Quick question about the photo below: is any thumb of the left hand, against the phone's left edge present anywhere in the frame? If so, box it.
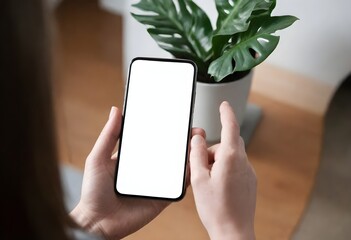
[88,107,122,164]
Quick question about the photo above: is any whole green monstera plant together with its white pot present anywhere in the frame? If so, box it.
[132,0,297,142]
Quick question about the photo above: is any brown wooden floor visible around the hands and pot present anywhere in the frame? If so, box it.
[56,0,323,240]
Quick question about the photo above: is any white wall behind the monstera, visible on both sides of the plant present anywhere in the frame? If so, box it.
[101,0,351,86]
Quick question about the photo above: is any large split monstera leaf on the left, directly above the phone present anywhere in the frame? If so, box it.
[132,0,213,71]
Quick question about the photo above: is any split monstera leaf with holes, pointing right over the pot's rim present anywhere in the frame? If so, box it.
[208,16,297,81]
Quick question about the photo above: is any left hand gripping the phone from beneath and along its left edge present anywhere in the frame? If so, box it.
[70,107,169,239]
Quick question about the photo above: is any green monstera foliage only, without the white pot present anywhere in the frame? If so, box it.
[132,0,297,83]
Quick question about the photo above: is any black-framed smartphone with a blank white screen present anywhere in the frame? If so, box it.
[115,58,197,200]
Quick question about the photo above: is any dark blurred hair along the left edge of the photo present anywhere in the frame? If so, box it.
[0,0,69,240]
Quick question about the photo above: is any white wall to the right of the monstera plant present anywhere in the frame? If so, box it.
[268,0,351,86]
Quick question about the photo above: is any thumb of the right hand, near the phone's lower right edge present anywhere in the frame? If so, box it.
[190,134,209,183]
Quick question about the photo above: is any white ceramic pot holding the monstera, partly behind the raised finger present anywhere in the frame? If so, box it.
[193,70,253,142]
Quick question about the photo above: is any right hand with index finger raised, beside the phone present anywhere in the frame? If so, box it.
[190,102,256,240]
